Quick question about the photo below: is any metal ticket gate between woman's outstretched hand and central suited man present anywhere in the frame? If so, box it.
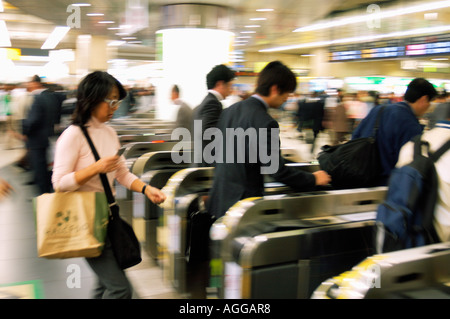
[158,163,332,294]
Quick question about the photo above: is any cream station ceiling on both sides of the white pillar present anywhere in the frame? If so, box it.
[0,0,450,54]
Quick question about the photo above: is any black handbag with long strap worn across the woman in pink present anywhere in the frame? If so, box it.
[81,127,142,269]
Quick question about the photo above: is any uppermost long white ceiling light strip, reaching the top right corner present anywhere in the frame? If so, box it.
[293,0,450,32]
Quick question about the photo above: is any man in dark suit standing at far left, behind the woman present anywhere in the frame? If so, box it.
[22,76,60,195]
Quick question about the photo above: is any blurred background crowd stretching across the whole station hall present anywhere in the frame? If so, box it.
[0,75,450,198]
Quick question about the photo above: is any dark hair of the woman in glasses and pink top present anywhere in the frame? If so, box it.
[72,71,127,125]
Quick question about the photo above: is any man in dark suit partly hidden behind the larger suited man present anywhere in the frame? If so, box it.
[192,64,235,167]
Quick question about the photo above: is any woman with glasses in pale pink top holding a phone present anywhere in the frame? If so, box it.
[52,71,166,298]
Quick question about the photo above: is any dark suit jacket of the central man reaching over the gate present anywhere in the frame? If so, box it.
[207,97,315,218]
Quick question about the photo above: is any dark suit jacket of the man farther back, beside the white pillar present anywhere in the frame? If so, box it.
[192,93,223,167]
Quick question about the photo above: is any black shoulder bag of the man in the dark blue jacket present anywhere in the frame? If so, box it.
[317,105,386,189]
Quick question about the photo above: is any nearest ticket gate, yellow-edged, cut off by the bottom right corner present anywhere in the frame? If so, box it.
[312,242,450,299]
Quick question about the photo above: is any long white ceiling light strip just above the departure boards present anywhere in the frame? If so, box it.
[259,25,450,52]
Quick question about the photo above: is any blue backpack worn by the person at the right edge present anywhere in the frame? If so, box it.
[375,135,450,253]
